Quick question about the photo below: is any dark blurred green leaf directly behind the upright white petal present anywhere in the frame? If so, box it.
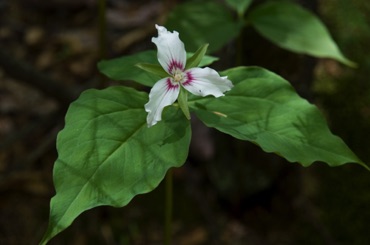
[166,1,243,53]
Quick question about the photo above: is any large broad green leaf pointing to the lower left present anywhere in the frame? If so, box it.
[41,87,191,244]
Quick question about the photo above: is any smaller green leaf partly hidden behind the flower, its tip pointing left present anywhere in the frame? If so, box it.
[98,50,218,87]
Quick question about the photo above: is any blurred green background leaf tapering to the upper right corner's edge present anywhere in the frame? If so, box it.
[249,1,355,67]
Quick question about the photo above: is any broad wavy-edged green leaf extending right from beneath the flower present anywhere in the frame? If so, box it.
[189,67,367,168]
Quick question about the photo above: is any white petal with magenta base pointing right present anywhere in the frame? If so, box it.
[182,67,233,97]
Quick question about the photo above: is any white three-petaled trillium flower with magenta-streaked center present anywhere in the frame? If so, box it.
[145,25,233,127]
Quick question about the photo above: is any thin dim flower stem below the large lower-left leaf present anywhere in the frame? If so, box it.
[164,169,173,245]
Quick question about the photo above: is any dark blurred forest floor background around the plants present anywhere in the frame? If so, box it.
[0,0,370,245]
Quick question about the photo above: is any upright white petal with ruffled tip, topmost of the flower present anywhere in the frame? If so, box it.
[152,25,186,75]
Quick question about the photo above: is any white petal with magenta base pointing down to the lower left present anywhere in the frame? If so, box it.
[145,78,180,127]
